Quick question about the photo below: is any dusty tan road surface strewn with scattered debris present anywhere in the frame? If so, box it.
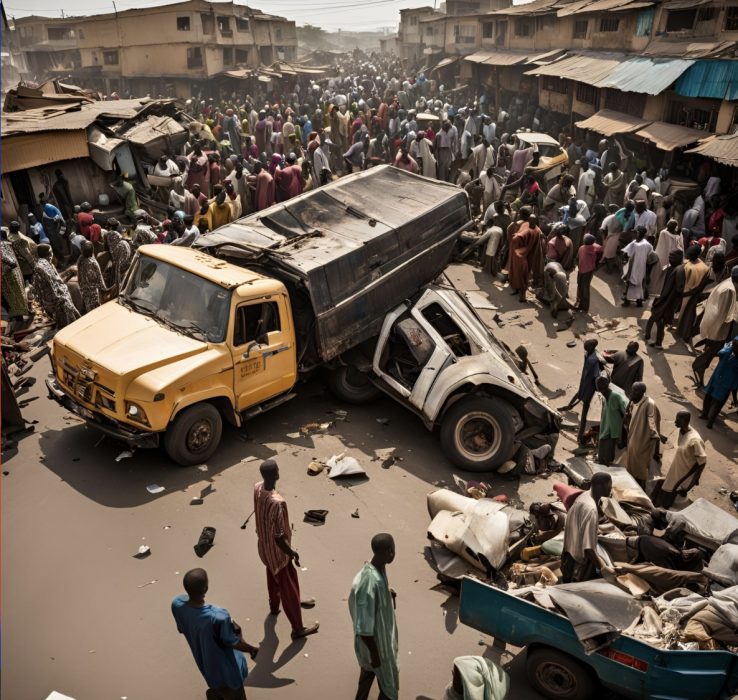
[2,266,738,700]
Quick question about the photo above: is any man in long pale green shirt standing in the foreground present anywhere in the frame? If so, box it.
[349,534,400,700]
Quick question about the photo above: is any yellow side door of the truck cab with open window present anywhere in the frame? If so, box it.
[231,295,297,411]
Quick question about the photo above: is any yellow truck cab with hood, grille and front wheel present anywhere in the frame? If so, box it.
[47,245,297,464]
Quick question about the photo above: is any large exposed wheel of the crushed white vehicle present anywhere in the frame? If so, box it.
[441,396,515,472]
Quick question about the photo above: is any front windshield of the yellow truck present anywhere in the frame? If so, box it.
[120,255,231,343]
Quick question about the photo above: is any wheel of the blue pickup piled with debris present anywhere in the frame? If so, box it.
[525,647,598,700]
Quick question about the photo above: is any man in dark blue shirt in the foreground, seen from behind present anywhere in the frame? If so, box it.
[172,569,259,700]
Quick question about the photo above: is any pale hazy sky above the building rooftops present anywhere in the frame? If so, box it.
[5,0,441,31]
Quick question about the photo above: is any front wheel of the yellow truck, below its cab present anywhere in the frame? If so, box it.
[164,403,223,467]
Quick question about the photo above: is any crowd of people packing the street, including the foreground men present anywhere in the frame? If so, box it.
[0,53,738,698]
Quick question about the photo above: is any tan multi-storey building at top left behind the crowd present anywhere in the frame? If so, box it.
[16,0,297,97]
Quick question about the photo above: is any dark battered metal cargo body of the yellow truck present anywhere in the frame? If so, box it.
[196,165,471,365]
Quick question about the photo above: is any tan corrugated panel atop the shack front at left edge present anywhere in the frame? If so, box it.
[3,129,90,173]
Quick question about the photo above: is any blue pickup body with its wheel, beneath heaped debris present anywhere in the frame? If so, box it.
[459,578,738,700]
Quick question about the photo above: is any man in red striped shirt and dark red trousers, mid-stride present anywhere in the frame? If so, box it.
[254,459,320,639]
